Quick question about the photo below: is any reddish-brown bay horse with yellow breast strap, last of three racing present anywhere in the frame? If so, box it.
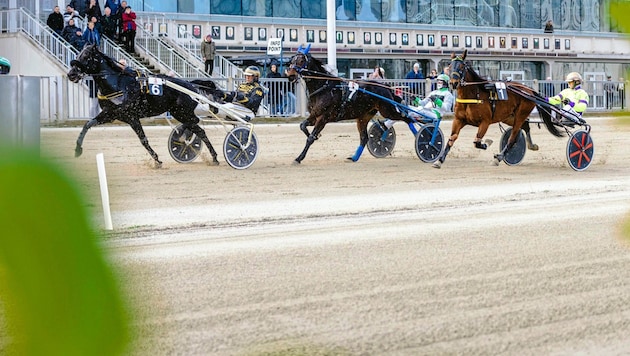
[433,50,562,168]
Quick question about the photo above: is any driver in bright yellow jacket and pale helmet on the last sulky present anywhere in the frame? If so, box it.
[547,72,588,125]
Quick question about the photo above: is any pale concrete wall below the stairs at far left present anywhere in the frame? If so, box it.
[0,33,66,76]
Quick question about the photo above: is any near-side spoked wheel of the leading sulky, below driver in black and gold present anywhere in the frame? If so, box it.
[223,126,258,169]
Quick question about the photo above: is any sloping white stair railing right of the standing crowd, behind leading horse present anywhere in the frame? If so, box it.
[136,26,208,78]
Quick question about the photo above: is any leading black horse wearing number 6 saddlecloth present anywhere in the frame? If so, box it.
[68,45,219,167]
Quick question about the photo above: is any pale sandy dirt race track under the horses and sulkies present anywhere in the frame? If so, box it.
[41,117,630,355]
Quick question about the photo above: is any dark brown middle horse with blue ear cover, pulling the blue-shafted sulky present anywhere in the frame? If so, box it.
[287,45,413,164]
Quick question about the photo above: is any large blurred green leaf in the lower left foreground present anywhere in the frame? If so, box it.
[0,148,129,356]
